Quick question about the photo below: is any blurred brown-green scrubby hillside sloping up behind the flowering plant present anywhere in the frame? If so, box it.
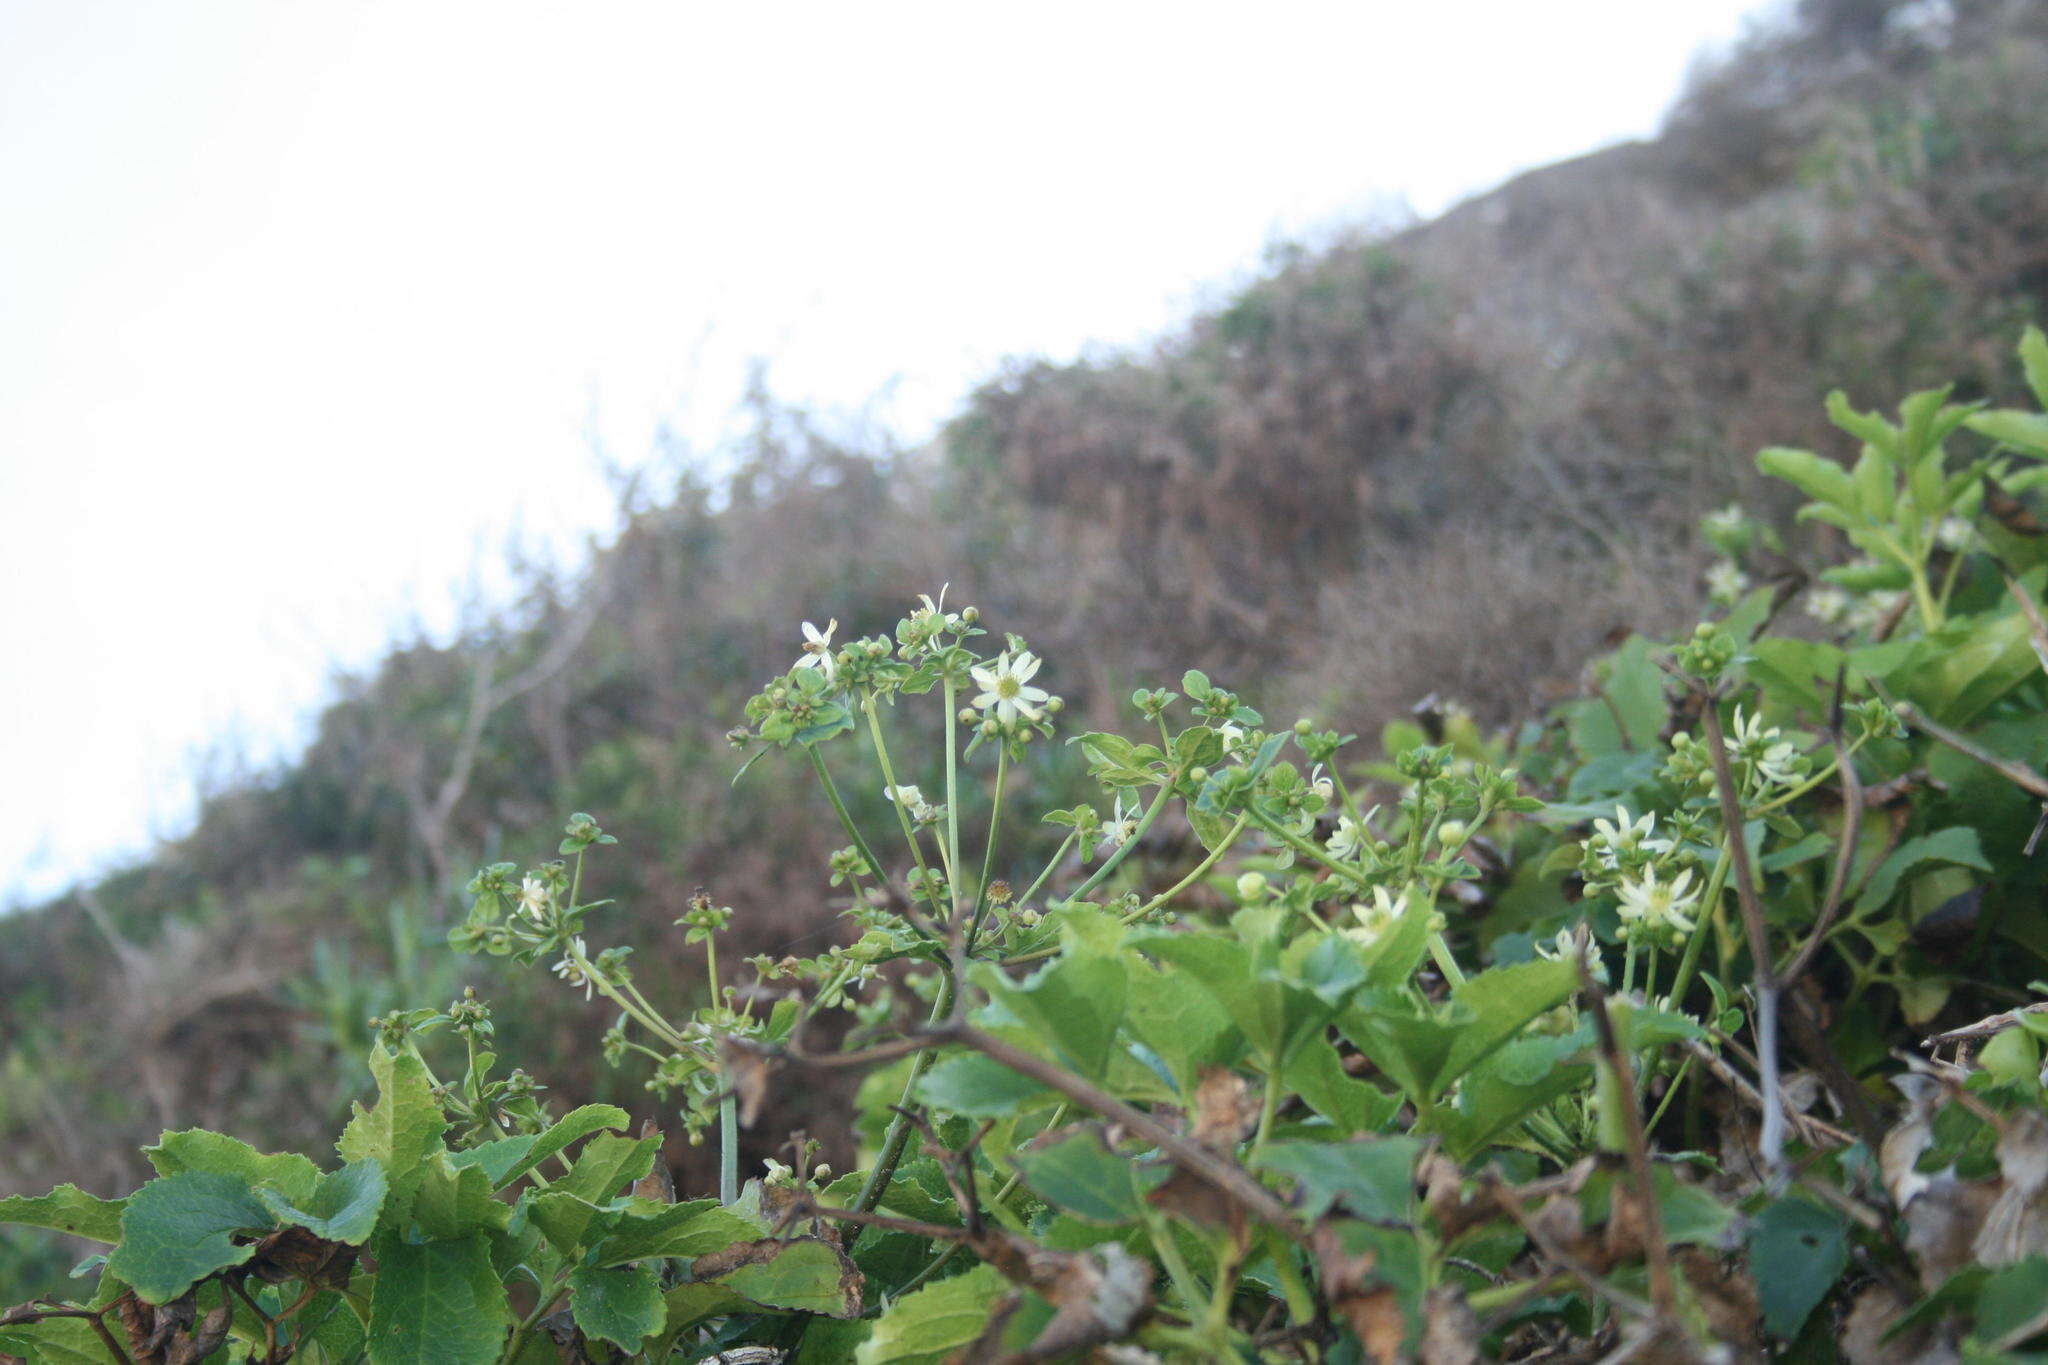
[0,0,2048,1302]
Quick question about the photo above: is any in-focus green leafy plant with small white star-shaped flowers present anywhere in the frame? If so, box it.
[12,332,2048,1365]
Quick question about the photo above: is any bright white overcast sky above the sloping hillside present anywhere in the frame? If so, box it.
[0,0,1767,902]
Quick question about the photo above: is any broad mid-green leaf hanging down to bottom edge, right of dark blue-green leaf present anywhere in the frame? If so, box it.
[369,1234,512,1365]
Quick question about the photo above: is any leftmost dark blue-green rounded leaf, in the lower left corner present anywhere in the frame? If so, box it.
[106,1171,274,1304]
